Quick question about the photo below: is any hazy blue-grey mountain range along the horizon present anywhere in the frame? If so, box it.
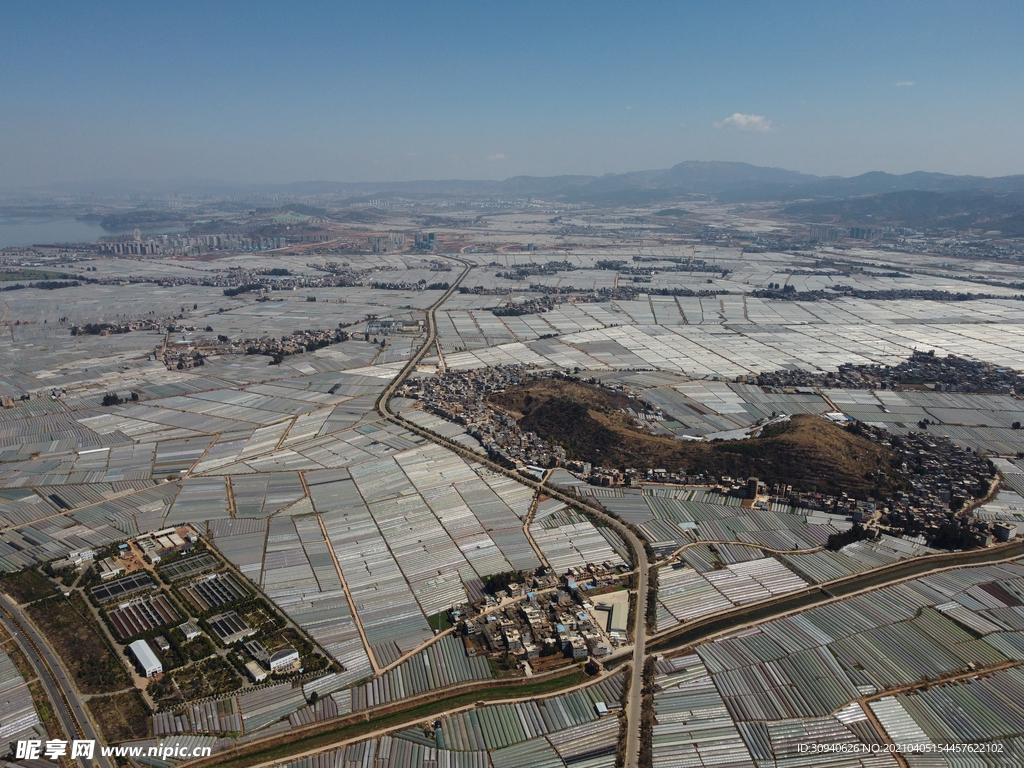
[11,161,1024,205]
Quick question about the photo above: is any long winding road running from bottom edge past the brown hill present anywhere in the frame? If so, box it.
[377,256,649,768]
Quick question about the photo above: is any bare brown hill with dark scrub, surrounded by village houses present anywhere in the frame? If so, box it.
[488,379,899,498]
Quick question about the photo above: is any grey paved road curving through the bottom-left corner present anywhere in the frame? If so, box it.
[0,595,113,768]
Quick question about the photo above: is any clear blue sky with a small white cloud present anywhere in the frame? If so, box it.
[0,0,1024,186]
